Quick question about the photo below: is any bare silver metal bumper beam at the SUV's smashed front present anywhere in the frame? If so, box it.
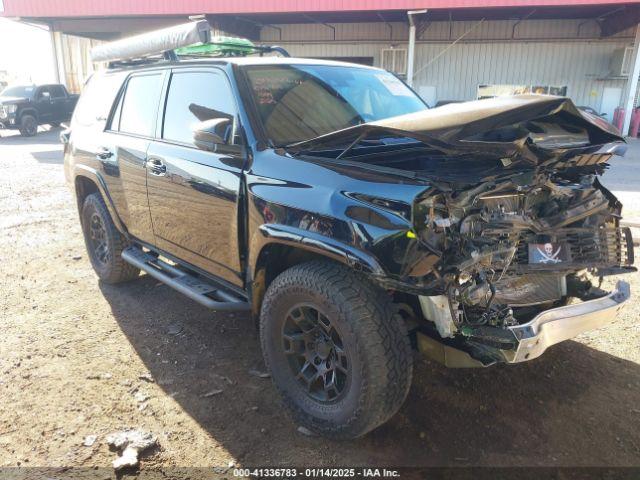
[503,281,631,363]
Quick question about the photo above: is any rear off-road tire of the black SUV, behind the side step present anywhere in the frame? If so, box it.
[80,193,140,283]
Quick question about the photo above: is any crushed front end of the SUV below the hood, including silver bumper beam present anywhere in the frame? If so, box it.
[414,163,635,364]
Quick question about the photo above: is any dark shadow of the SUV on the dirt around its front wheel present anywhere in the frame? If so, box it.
[100,276,640,466]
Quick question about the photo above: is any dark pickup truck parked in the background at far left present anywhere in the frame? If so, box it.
[0,84,78,137]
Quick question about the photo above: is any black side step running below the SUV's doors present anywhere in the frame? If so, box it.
[122,247,251,310]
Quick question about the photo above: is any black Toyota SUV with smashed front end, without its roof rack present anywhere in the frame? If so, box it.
[62,24,634,438]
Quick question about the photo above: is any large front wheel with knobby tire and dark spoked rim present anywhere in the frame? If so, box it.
[260,261,412,438]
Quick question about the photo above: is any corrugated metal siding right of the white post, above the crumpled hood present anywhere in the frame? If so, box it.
[414,42,627,109]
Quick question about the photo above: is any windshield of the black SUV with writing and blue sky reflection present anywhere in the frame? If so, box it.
[244,65,427,146]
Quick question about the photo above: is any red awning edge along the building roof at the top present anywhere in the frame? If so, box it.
[0,0,639,18]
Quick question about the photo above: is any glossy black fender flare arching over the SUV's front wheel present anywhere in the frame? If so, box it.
[249,224,386,278]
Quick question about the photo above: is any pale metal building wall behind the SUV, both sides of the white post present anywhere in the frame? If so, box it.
[261,20,633,110]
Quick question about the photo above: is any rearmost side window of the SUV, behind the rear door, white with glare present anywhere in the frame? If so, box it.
[72,74,123,128]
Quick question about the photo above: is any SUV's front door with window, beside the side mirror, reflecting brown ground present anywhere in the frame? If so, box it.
[147,67,243,285]
